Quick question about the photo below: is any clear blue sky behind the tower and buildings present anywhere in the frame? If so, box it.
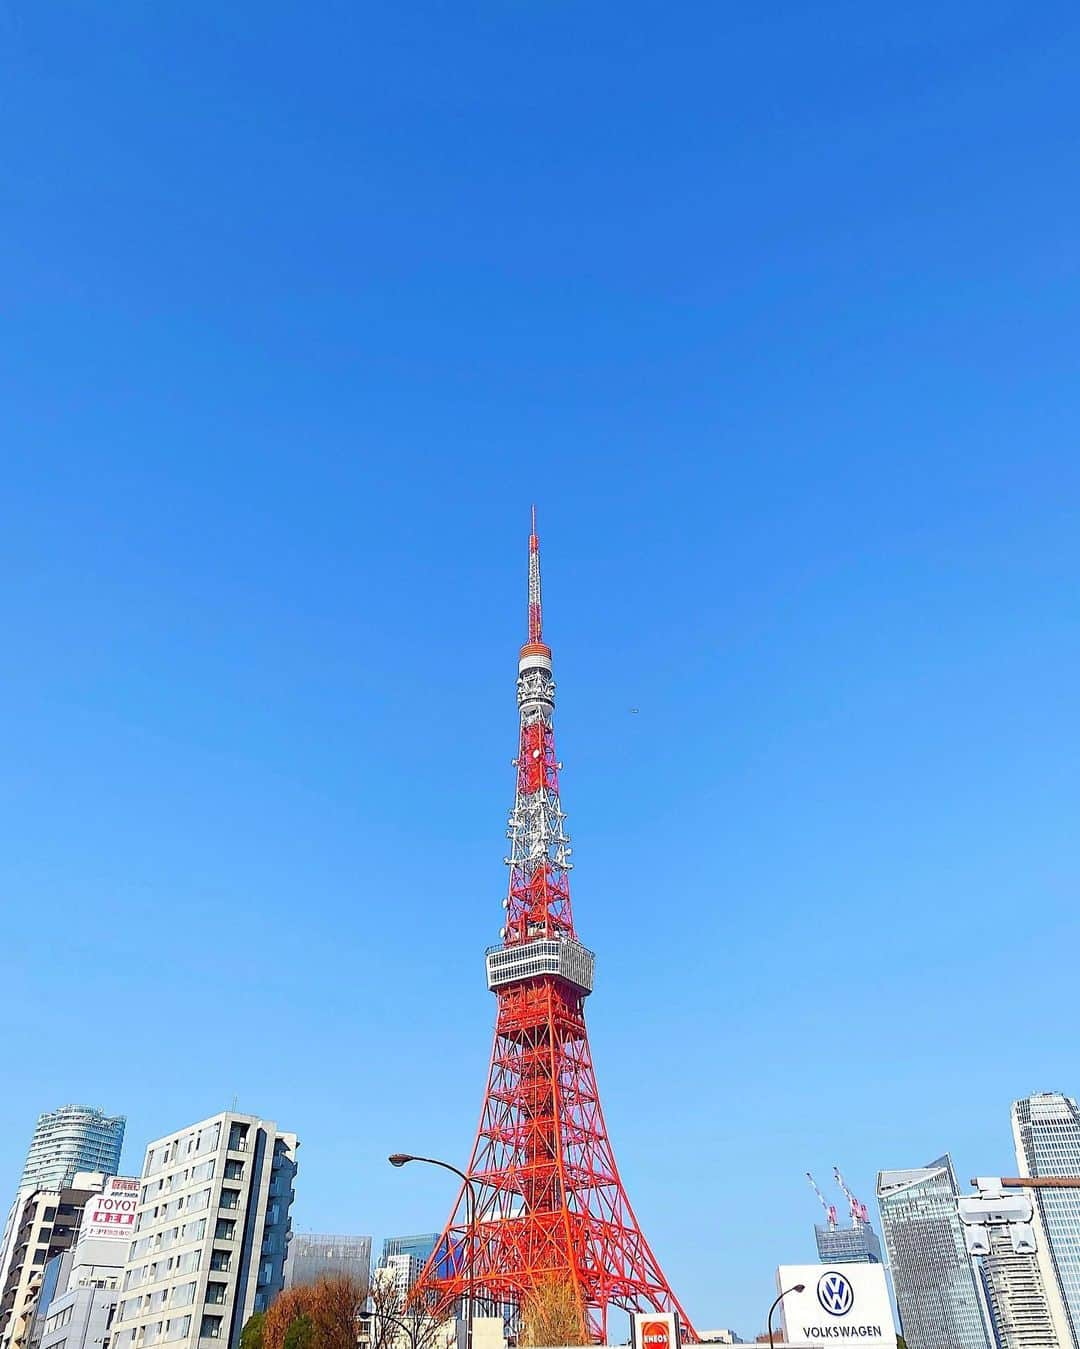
[0,0,1080,1334]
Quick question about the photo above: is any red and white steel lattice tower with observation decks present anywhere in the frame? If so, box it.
[415,511,696,1342]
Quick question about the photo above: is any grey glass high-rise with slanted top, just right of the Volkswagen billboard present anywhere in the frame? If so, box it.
[878,1153,992,1349]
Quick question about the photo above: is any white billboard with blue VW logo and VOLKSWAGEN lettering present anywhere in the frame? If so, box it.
[777,1264,897,1349]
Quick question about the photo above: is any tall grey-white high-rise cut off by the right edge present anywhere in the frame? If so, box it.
[1013,1091,1080,1349]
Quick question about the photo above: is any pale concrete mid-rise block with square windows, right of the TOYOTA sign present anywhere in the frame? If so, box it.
[111,1110,298,1349]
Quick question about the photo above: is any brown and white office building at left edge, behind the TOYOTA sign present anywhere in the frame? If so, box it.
[0,1172,105,1349]
